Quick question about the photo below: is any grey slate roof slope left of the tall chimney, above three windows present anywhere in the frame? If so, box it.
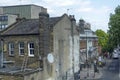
[3,19,39,35]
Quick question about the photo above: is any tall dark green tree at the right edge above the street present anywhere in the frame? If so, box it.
[108,5,120,48]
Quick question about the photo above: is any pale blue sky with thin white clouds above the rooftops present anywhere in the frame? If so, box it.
[0,0,120,32]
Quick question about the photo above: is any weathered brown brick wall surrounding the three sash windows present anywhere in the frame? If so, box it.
[4,35,39,68]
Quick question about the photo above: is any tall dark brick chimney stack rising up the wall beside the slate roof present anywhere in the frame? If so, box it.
[39,12,49,56]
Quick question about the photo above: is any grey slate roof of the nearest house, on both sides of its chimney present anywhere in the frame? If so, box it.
[1,17,62,35]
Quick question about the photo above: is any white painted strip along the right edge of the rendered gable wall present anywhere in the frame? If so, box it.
[70,35,80,74]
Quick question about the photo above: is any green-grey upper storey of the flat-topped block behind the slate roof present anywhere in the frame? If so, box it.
[0,4,47,19]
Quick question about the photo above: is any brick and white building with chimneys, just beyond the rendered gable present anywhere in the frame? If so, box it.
[78,19,98,64]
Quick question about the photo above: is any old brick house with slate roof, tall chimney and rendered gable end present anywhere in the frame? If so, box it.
[0,13,79,80]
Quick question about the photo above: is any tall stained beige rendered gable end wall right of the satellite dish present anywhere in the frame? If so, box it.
[53,14,79,80]
